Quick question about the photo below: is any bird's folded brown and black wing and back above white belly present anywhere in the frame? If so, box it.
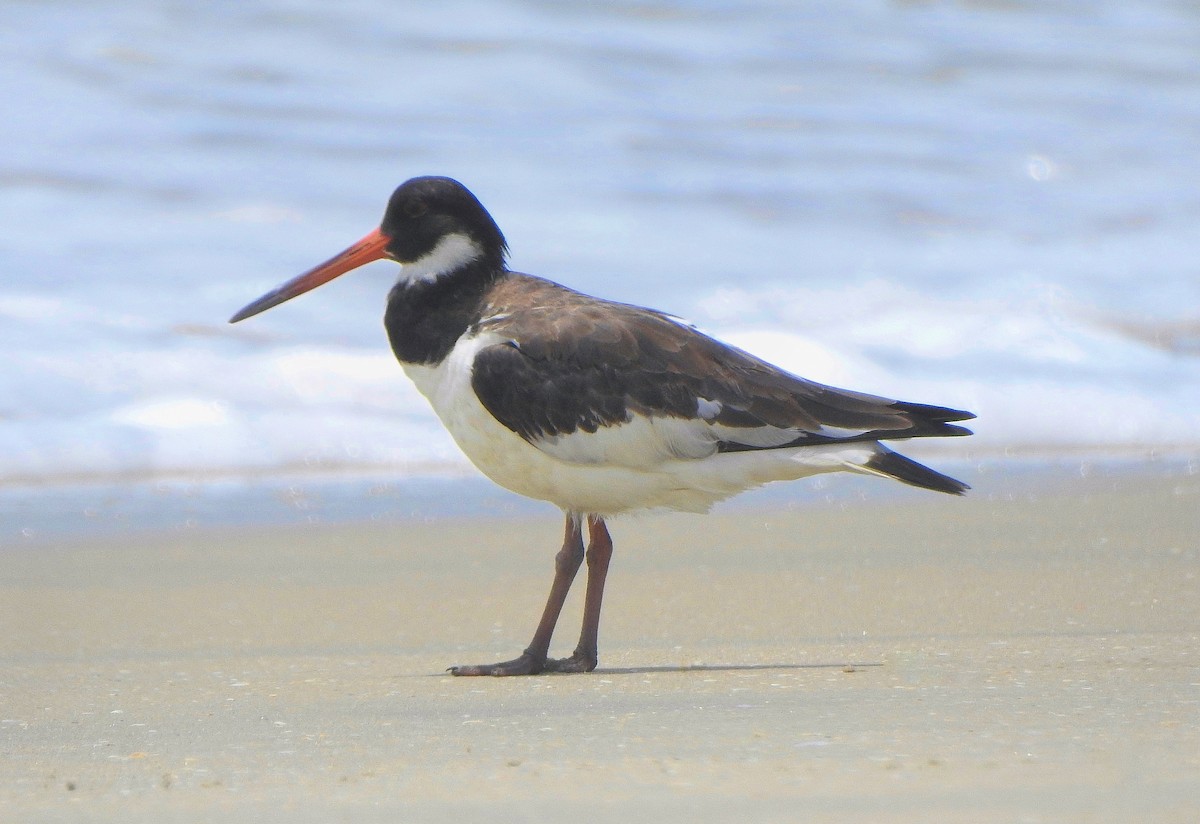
[472,276,973,451]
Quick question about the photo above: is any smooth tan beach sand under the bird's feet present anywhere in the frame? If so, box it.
[0,473,1200,823]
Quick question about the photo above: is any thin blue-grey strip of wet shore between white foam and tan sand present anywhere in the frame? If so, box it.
[0,450,1198,544]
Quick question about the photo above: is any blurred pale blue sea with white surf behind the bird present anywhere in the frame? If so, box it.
[0,0,1200,541]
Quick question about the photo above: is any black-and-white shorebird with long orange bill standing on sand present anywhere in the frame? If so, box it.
[229,176,974,675]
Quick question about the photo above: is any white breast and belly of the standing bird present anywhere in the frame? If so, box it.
[403,333,874,516]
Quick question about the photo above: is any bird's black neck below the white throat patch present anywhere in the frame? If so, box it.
[384,260,506,365]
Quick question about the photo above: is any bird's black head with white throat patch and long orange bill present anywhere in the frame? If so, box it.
[229,178,508,323]
